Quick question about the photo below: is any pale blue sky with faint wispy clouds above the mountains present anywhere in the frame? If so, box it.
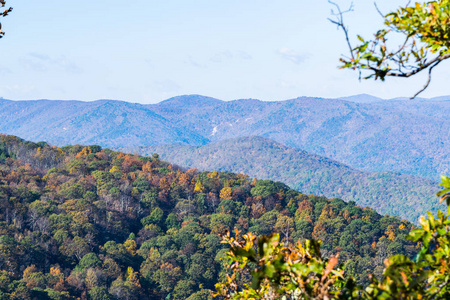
[0,0,450,103]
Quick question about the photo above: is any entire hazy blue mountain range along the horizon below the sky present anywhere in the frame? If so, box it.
[0,95,450,181]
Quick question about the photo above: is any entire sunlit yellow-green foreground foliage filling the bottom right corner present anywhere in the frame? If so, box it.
[216,176,450,299]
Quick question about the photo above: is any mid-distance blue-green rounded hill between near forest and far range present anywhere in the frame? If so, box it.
[128,137,444,222]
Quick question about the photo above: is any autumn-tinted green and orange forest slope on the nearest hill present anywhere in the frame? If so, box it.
[0,135,419,300]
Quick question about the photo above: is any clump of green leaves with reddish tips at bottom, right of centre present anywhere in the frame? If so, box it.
[215,229,354,299]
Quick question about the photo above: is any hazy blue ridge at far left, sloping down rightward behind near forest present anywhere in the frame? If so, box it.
[0,99,209,146]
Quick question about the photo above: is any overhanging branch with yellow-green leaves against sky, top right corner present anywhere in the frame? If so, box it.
[329,0,450,99]
